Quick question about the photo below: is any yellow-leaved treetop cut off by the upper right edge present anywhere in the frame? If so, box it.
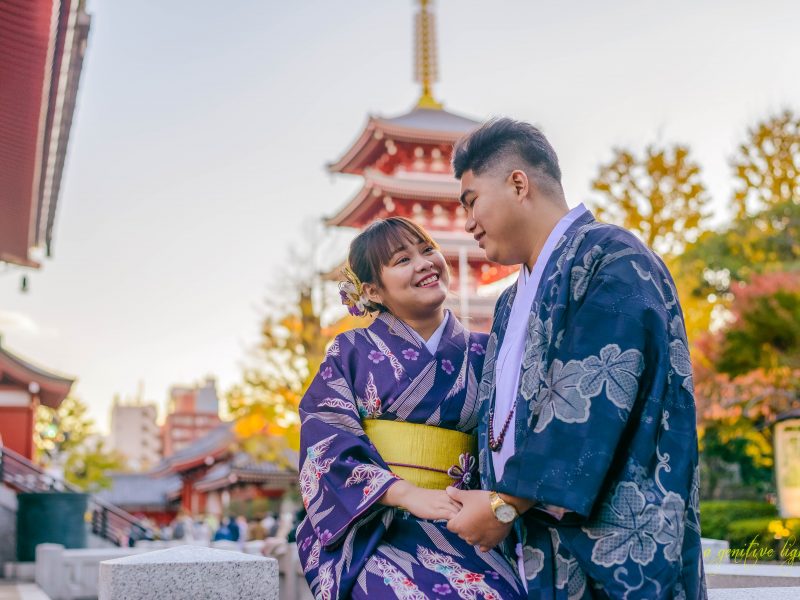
[731,110,800,221]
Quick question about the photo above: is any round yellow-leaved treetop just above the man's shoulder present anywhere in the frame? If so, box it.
[592,144,709,259]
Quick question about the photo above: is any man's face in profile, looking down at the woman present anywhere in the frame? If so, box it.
[461,171,526,265]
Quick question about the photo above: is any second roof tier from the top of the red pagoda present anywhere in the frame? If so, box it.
[325,169,461,227]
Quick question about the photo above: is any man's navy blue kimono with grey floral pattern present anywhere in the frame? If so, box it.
[479,212,706,599]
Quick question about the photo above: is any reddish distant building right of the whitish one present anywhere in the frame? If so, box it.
[163,377,222,457]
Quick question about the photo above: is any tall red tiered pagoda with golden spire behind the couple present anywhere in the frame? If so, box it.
[326,0,515,331]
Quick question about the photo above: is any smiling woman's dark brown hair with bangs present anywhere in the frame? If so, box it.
[347,217,439,311]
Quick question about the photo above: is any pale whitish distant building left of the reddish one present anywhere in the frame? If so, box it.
[110,400,161,471]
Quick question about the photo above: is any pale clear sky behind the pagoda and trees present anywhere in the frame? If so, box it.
[0,0,800,430]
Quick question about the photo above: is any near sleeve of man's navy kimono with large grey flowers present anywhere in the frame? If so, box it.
[497,260,663,520]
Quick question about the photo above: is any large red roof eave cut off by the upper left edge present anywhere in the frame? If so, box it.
[0,0,90,267]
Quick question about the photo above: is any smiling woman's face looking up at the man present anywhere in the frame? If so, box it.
[365,240,450,319]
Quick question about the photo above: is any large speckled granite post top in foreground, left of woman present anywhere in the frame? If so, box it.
[98,546,279,600]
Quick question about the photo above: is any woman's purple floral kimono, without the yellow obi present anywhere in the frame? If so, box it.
[297,313,525,600]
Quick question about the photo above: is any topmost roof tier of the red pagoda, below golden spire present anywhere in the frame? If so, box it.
[328,108,480,175]
